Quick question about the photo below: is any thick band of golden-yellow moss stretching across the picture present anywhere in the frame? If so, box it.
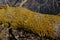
[0,7,60,37]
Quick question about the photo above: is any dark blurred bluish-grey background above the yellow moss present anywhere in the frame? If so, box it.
[0,0,60,14]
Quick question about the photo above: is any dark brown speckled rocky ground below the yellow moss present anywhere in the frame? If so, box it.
[0,27,56,40]
